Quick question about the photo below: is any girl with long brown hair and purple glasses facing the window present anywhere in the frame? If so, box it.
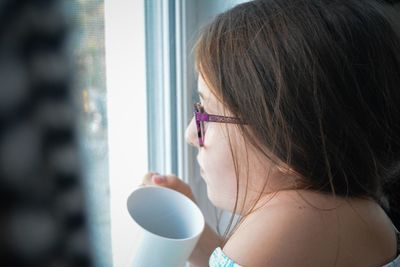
[144,0,400,267]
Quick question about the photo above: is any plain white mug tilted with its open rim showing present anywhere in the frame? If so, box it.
[127,186,205,267]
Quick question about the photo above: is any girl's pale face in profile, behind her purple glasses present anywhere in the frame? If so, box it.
[186,75,290,214]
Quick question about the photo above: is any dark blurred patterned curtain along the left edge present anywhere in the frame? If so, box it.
[0,0,92,267]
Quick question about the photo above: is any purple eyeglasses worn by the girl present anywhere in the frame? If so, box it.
[194,103,245,147]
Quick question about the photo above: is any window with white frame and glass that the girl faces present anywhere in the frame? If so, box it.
[74,0,248,266]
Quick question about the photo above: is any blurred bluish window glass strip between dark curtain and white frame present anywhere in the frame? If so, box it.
[70,0,112,267]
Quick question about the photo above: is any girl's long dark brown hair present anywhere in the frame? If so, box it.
[195,0,400,243]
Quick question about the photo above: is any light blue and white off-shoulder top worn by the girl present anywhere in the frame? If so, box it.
[209,229,400,267]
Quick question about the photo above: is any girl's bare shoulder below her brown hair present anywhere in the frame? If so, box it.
[223,192,396,267]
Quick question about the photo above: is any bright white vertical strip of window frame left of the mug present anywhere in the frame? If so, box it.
[105,0,148,267]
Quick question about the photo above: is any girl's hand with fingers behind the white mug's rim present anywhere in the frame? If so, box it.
[142,172,196,203]
